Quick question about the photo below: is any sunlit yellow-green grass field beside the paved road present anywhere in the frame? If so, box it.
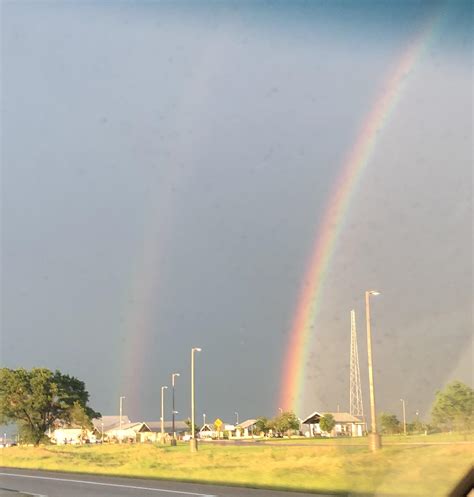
[1,443,473,497]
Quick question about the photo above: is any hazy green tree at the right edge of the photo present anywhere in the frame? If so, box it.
[431,381,474,431]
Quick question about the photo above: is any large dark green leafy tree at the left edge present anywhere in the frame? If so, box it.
[0,368,100,445]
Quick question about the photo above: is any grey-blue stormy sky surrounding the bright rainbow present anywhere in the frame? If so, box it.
[1,0,473,422]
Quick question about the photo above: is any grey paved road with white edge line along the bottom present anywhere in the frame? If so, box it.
[0,467,334,497]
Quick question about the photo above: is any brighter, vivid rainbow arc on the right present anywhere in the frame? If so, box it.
[278,13,440,413]
